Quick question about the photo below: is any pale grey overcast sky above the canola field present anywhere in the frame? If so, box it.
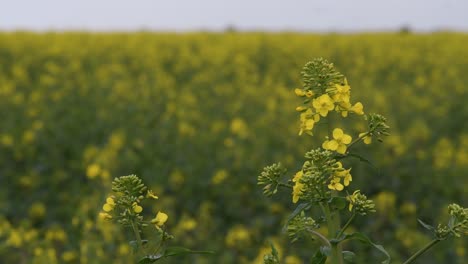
[0,0,468,32]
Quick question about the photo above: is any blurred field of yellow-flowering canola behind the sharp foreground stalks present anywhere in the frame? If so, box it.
[0,32,468,264]
